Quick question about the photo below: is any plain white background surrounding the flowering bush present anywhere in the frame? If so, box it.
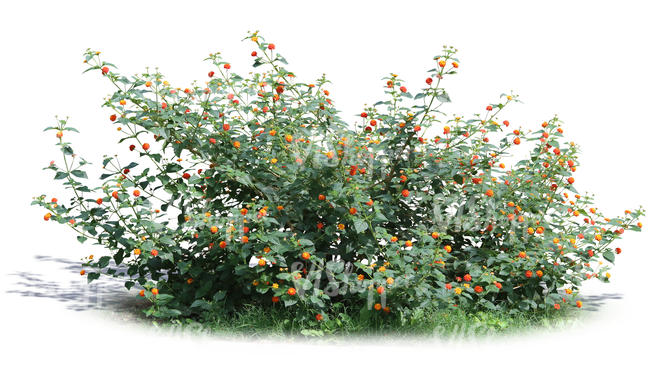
[0,1,650,367]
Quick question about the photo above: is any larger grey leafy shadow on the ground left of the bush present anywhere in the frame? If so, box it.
[7,255,148,319]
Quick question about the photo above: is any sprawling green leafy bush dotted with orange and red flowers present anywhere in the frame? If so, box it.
[33,34,644,324]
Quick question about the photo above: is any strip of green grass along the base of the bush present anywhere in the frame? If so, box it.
[151,306,582,339]
